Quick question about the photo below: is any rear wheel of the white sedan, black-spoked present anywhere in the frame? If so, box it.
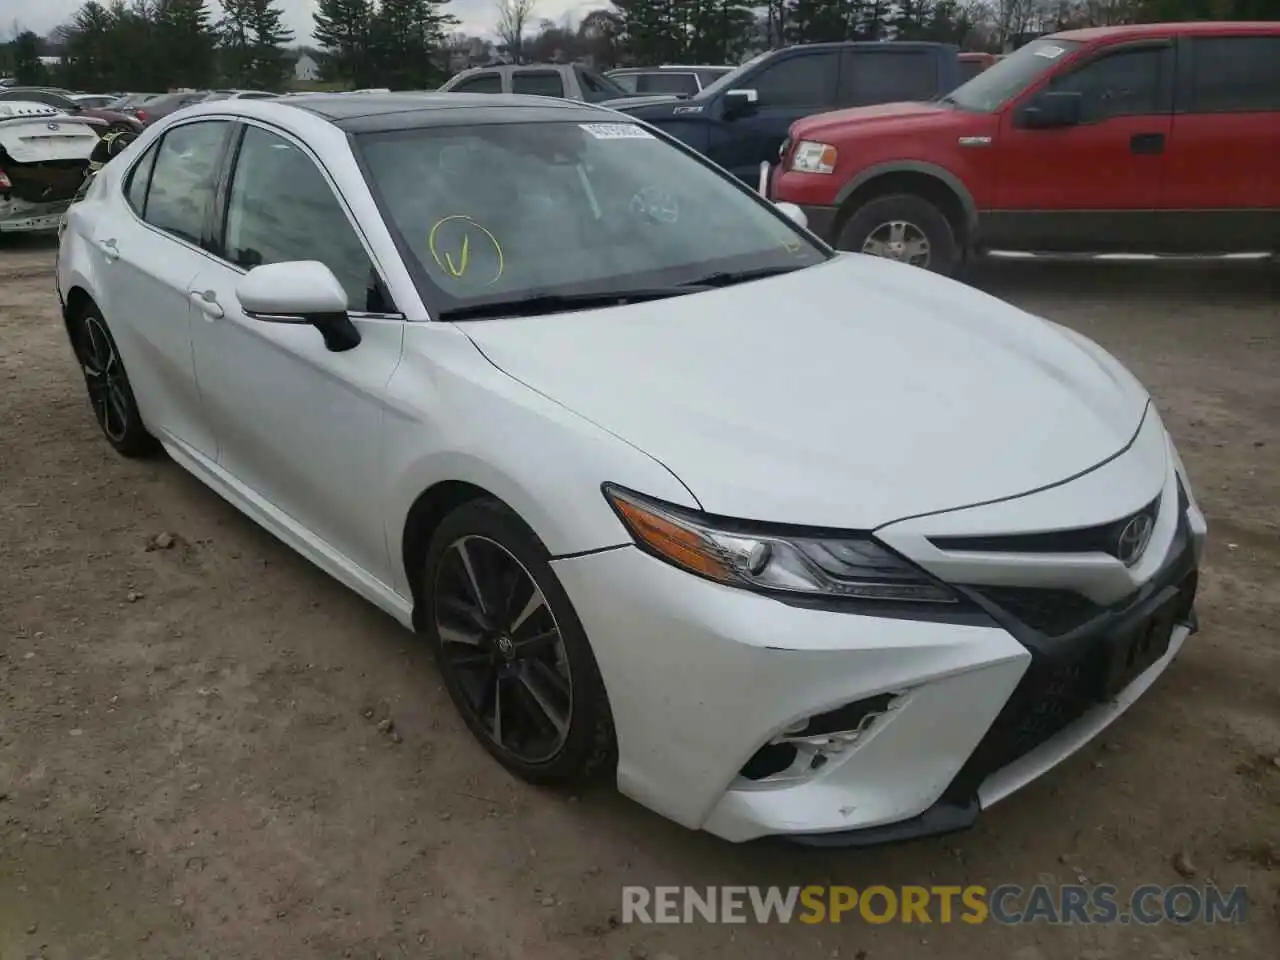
[70,303,160,458]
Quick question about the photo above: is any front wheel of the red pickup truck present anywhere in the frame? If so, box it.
[836,193,959,274]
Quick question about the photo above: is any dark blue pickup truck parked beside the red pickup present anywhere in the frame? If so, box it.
[617,41,961,184]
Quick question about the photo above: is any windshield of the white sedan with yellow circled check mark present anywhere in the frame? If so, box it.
[358,122,827,315]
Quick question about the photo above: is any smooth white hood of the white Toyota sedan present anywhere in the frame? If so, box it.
[461,255,1147,530]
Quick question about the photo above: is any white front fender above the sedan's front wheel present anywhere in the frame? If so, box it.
[384,320,699,596]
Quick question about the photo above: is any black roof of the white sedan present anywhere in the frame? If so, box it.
[250,92,617,133]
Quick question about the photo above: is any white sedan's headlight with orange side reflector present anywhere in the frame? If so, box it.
[604,484,957,603]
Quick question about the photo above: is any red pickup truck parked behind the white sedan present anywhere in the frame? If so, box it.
[768,22,1280,273]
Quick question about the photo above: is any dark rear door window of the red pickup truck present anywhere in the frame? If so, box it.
[1184,37,1280,112]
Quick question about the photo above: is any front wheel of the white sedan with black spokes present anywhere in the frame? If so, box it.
[420,499,616,786]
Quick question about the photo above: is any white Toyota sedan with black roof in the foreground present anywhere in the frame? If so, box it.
[58,93,1204,845]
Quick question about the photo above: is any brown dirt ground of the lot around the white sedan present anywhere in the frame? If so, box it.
[0,241,1280,960]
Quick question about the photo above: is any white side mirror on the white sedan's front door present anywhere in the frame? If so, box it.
[236,260,360,353]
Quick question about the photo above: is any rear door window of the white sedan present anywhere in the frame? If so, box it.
[142,120,230,243]
